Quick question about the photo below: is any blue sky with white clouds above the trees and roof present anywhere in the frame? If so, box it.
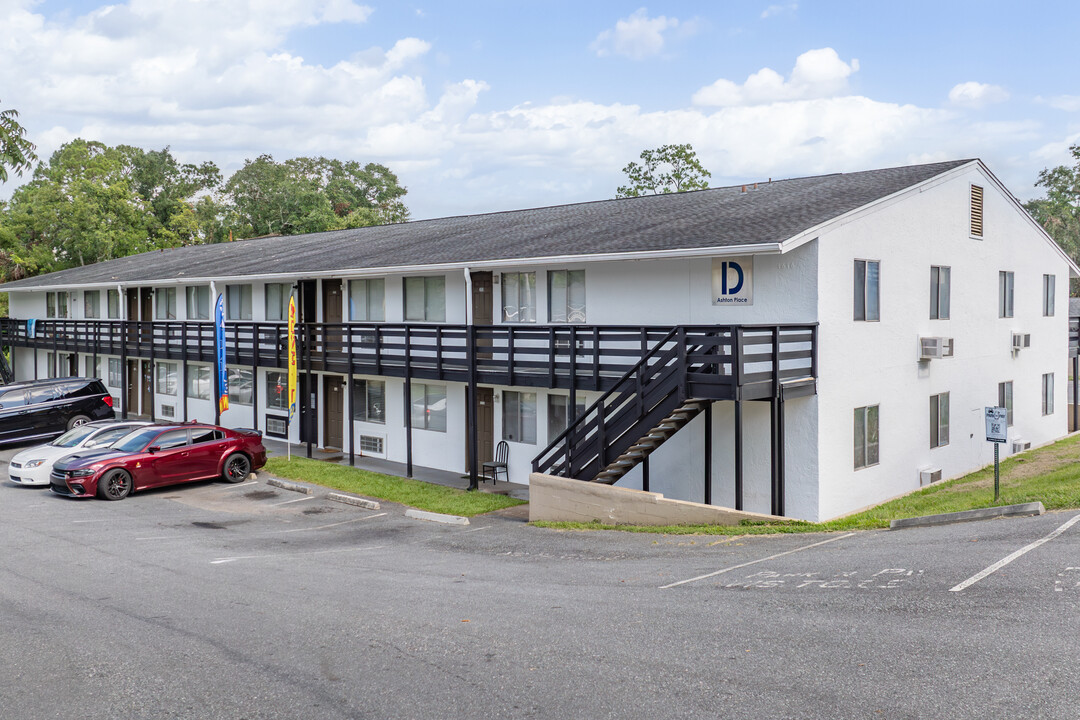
[0,0,1080,218]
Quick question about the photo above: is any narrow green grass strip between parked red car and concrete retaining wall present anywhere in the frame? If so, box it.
[265,458,525,517]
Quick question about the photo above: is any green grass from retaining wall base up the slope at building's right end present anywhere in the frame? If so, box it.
[534,435,1080,535]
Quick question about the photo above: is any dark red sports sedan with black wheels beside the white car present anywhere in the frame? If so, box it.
[50,424,267,500]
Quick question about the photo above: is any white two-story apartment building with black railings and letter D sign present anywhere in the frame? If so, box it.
[0,160,1078,519]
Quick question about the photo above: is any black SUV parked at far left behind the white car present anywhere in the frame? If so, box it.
[0,378,116,443]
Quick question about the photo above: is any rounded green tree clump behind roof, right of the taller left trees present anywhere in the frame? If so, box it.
[225,154,408,236]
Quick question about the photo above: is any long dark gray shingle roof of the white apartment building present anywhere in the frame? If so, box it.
[0,160,973,290]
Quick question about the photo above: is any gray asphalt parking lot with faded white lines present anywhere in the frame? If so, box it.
[0,450,1080,719]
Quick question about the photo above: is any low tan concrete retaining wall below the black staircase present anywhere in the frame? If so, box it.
[529,473,784,525]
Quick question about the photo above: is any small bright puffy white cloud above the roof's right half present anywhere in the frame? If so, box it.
[692,47,859,107]
